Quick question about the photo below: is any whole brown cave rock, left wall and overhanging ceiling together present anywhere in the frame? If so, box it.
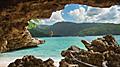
[0,0,120,52]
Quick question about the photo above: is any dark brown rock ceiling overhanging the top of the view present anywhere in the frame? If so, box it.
[0,0,120,23]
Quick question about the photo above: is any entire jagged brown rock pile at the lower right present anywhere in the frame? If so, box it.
[60,35,120,67]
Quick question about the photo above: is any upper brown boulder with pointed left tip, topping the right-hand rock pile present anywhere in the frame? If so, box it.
[81,35,118,52]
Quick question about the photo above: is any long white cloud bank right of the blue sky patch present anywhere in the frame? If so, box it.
[69,6,120,23]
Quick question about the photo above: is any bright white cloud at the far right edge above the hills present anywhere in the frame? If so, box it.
[96,6,120,23]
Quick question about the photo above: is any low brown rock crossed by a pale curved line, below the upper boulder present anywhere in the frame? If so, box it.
[60,46,105,67]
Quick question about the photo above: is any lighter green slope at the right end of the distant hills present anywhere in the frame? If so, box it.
[78,24,120,35]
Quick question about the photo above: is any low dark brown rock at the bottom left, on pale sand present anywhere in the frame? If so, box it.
[8,55,55,67]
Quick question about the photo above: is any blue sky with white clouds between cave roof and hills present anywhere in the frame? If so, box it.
[37,4,120,25]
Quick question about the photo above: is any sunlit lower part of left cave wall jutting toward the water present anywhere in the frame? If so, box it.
[0,28,44,52]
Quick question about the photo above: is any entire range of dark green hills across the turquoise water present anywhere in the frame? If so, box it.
[30,22,120,36]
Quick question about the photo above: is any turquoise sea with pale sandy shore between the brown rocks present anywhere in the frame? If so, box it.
[0,35,120,67]
